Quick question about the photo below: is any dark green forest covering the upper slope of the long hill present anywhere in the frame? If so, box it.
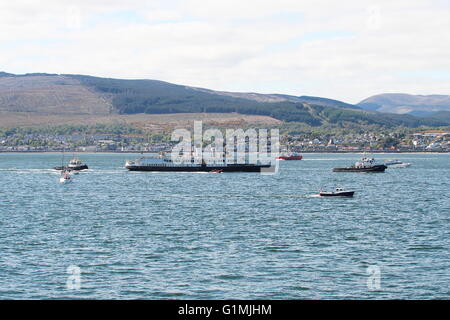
[71,76,450,127]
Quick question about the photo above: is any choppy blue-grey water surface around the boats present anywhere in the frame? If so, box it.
[0,154,450,299]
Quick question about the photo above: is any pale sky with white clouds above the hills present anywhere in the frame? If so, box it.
[0,0,450,103]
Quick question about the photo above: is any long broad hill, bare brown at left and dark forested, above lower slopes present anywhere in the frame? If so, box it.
[0,73,450,127]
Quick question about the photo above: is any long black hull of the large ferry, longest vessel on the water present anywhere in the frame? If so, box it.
[125,165,270,172]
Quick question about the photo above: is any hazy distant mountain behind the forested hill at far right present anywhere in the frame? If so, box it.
[357,93,450,116]
